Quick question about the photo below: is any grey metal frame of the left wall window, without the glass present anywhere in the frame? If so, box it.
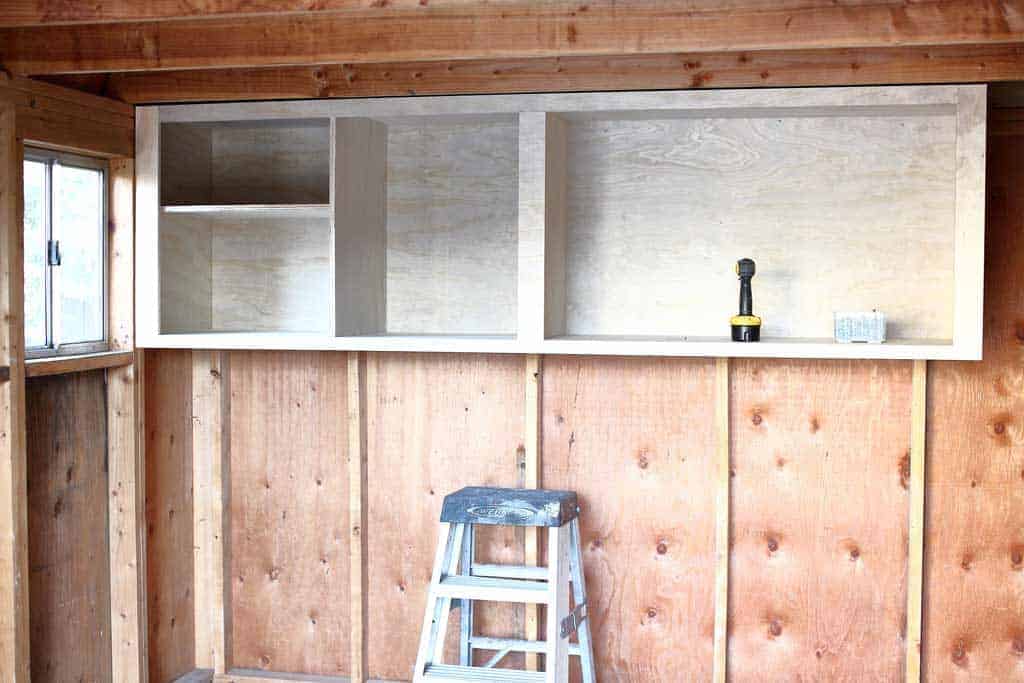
[22,145,111,359]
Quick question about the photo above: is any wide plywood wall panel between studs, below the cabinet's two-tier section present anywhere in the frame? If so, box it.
[228,352,349,676]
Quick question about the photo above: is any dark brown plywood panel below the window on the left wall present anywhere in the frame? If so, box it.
[26,371,111,683]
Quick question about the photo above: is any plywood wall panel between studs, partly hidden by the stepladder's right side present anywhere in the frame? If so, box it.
[542,357,716,682]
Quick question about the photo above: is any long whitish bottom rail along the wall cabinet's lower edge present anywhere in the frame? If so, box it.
[138,332,966,360]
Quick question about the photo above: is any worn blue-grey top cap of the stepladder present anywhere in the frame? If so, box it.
[441,486,580,526]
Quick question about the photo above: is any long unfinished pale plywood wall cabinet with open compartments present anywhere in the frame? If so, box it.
[137,86,985,358]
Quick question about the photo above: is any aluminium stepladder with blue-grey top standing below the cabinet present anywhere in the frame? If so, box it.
[413,486,595,683]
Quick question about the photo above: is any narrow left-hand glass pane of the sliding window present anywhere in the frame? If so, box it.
[25,161,47,348]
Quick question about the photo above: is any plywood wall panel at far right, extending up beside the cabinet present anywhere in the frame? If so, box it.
[923,121,1024,681]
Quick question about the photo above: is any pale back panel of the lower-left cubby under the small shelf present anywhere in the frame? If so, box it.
[210,212,332,333]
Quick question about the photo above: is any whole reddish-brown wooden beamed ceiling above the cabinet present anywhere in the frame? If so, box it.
[0,0,1024,102]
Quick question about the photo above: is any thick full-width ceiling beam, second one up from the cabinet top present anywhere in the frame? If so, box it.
[0,0,1024,75]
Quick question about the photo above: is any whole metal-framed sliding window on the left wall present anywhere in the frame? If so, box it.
[24,150,108,357]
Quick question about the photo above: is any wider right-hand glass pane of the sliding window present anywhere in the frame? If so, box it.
[53,164,105,344]
